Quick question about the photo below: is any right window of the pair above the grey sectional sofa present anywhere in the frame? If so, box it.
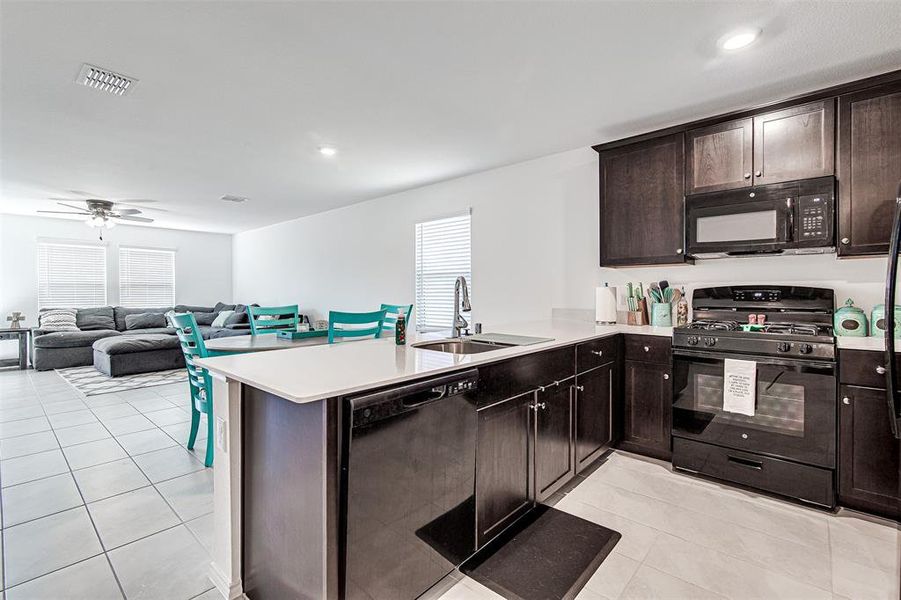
[119,247,175,307]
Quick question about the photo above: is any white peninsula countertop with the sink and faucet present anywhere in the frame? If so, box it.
[198,320,673,403]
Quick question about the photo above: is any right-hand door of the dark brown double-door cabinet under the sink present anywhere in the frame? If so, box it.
[535,378,576,502]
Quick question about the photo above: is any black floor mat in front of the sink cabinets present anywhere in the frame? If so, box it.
[460,505,622,600]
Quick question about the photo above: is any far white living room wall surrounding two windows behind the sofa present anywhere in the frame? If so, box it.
[0,215,232,355]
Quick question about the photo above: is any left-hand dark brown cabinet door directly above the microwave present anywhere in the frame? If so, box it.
[685,119,754,194]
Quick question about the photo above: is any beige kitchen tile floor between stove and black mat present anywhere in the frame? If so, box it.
[441,452,901,600]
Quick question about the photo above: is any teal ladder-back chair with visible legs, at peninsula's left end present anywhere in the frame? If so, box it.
[169,312,213,467]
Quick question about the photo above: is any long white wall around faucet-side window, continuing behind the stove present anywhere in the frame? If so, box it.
[233,148,885,326]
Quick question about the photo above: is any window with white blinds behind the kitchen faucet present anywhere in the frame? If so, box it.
[413,213,472,331]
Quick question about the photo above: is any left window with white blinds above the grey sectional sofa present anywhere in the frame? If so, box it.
[38,241,106,308]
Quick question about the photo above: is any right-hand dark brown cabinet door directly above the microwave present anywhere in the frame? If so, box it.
[753,98,835,185]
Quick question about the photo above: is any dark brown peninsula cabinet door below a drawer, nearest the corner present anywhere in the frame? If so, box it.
[573,362,617,472]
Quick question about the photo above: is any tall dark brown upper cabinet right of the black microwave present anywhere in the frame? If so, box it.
[838,82,901,256]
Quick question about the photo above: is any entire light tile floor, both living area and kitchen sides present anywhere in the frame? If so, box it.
[0,371,901,600]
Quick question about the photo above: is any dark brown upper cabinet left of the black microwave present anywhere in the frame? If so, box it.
[600,133,685,267]
